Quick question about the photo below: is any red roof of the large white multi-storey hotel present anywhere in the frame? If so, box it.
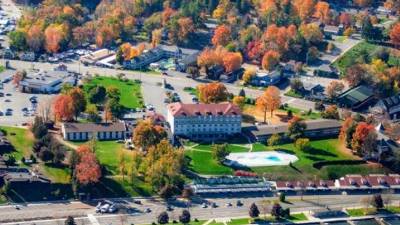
[167,102,241,116]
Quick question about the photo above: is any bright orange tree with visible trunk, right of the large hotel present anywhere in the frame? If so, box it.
[256,86,281,123]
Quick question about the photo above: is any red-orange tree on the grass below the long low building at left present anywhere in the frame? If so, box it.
[75,151,101,185]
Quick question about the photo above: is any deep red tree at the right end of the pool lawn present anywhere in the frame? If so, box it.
[351,122,375,155]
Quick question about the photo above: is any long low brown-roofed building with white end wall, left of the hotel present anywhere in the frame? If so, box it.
[61,122,127,141]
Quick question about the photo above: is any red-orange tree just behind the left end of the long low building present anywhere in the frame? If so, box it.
[53,95,74,121]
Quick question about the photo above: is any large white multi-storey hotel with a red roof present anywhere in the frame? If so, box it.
[167,103,242,140]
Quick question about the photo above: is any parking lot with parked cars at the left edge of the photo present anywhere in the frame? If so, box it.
[0,77,52,126]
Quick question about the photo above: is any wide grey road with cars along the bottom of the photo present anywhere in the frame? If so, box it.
[0,195,400,225]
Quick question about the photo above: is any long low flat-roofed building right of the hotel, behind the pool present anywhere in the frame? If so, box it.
[243,119,342,142]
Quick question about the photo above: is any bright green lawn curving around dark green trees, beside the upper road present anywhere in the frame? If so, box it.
[84,77,143,108]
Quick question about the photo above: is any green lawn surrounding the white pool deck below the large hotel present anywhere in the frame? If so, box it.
[185,139,388,180]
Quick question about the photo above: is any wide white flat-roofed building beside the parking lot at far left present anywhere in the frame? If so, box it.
[19,70,77,93]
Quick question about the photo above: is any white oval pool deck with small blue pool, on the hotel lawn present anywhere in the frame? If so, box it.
[226,151,299,167]
